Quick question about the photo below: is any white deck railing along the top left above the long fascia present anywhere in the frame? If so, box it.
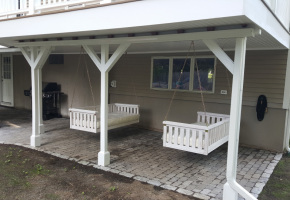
[0,0,127,20]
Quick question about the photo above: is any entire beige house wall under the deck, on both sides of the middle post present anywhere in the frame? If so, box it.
[14,50,287,151]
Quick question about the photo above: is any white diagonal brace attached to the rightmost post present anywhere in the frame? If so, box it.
[203,40,234,74]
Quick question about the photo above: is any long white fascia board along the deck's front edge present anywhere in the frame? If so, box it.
[0,0,243,38]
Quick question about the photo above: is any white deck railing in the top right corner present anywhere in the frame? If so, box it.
[262,0,290,30]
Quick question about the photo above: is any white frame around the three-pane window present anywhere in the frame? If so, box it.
[150,56,217,94]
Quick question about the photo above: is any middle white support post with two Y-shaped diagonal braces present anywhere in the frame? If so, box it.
[83,43,130,166]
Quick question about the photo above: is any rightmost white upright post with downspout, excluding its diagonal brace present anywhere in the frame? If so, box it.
[223,38,256,200]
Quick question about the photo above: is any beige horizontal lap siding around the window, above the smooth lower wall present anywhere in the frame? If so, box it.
[110,51,287,108]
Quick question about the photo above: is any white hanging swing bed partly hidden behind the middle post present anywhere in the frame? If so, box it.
[69,103,140,133]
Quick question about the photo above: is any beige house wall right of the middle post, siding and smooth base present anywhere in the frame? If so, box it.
[109,51,287,151]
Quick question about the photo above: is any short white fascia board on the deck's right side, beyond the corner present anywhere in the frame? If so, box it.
[244,0,290,49]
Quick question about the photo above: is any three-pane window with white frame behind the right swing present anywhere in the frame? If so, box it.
[151,57,216,93]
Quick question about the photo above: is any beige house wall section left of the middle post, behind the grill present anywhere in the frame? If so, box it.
[14,55,100,116]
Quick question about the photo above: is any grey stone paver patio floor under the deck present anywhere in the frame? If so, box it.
[0,107,282,200]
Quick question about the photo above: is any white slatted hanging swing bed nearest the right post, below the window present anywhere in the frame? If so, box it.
[163,112,230,155]
